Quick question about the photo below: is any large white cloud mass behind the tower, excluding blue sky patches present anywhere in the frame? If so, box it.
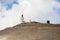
[0,0,60,29]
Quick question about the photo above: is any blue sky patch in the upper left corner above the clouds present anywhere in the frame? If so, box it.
[0,0,18,10]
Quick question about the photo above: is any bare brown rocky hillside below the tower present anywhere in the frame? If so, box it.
[0,23,60,40]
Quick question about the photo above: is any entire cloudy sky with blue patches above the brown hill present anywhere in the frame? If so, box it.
[0,0,60,30]
